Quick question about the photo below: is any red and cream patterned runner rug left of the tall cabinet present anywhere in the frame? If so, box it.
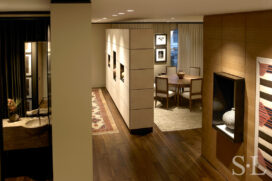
[92,89,119,135]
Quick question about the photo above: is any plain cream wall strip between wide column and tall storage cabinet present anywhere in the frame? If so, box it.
[91,24,111,87]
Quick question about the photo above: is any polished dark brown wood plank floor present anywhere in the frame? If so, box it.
[93,89,225,181]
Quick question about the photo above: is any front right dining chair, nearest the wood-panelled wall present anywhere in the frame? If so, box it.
[180,78,202,111]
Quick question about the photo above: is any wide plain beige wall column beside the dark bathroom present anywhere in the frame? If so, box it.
[51,3,93,181]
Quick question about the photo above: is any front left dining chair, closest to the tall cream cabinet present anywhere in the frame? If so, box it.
[155,77,176,109]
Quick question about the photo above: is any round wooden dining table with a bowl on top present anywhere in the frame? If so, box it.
[158,74,201,105]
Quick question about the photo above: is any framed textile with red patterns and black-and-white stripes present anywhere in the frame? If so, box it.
[254,57,272,178]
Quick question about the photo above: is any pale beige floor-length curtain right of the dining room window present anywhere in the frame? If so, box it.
[178,24,203,76]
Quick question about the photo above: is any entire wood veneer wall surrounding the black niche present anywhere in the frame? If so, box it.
[202,11,272,181]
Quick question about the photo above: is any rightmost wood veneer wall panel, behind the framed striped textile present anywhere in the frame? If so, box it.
[245,11,272,181]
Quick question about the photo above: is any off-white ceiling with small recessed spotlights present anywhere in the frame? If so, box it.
[0,0,272,23]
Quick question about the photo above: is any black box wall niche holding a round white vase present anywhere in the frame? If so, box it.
[212,72,245,143]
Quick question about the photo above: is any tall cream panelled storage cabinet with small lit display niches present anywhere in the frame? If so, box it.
[106,29,154,131]
